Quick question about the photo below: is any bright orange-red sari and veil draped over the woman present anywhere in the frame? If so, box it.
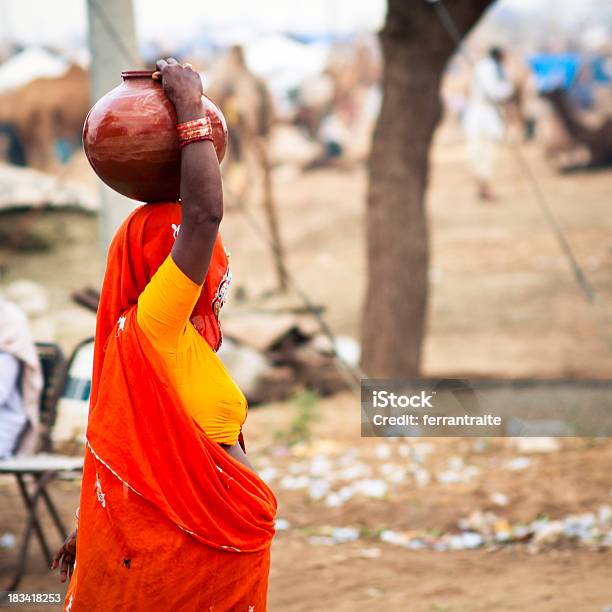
[64,204,276,612]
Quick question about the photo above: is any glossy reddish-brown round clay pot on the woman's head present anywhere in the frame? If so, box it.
[83,70,227,202]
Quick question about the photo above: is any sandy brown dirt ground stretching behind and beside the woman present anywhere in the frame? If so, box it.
[0,129,612,612]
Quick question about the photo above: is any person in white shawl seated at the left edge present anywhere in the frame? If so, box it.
[0,298,43,458]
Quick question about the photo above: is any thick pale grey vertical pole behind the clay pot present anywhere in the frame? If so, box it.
[87,0,141,254]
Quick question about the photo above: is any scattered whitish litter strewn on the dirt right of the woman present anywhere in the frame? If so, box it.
[261,430,612,559]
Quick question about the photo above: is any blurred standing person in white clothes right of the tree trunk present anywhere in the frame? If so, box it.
[463,47,514,201]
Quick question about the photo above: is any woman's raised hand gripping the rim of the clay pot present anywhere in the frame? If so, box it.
[153,57,203,123]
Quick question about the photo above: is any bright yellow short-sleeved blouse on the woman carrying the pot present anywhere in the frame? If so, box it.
[136,255,246,444]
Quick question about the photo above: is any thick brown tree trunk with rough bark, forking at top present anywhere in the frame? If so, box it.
[362,0,492,378]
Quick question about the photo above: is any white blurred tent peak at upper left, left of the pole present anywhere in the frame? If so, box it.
[0,47,70,92]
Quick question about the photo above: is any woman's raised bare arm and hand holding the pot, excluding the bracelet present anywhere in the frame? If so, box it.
[157,58,223,285]
